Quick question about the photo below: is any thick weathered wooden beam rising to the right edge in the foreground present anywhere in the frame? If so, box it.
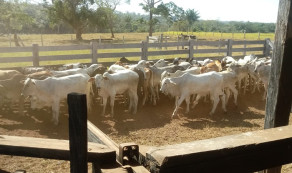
[146,126,292,172]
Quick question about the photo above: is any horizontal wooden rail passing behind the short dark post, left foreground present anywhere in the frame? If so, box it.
[0,135,116,165]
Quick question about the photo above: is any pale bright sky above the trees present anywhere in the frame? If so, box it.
[116,0,279,23]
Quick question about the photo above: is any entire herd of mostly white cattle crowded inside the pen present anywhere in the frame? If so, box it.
[0,55,271,124]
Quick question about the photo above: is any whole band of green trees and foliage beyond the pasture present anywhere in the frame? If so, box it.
[0,0,275,39]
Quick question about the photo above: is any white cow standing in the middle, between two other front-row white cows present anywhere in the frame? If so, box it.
[88,70,139,116]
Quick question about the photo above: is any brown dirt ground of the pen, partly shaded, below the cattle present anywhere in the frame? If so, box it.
[0,93,292,173]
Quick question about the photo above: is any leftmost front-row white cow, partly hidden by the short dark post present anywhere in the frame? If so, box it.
[22,74,92,125]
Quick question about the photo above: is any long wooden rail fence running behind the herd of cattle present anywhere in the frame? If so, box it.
[0,39,273,66]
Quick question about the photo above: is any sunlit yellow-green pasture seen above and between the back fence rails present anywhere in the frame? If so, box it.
[0,31,274,68]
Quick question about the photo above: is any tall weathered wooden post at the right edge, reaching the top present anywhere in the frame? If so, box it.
[264,0,292,173]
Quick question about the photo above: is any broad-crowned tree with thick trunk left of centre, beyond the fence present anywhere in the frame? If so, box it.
[47,0,94,40]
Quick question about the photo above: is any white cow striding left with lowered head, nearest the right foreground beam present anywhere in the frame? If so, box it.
[160,72,226,117]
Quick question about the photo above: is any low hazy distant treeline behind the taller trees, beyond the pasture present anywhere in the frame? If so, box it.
[0,0,275,34]
